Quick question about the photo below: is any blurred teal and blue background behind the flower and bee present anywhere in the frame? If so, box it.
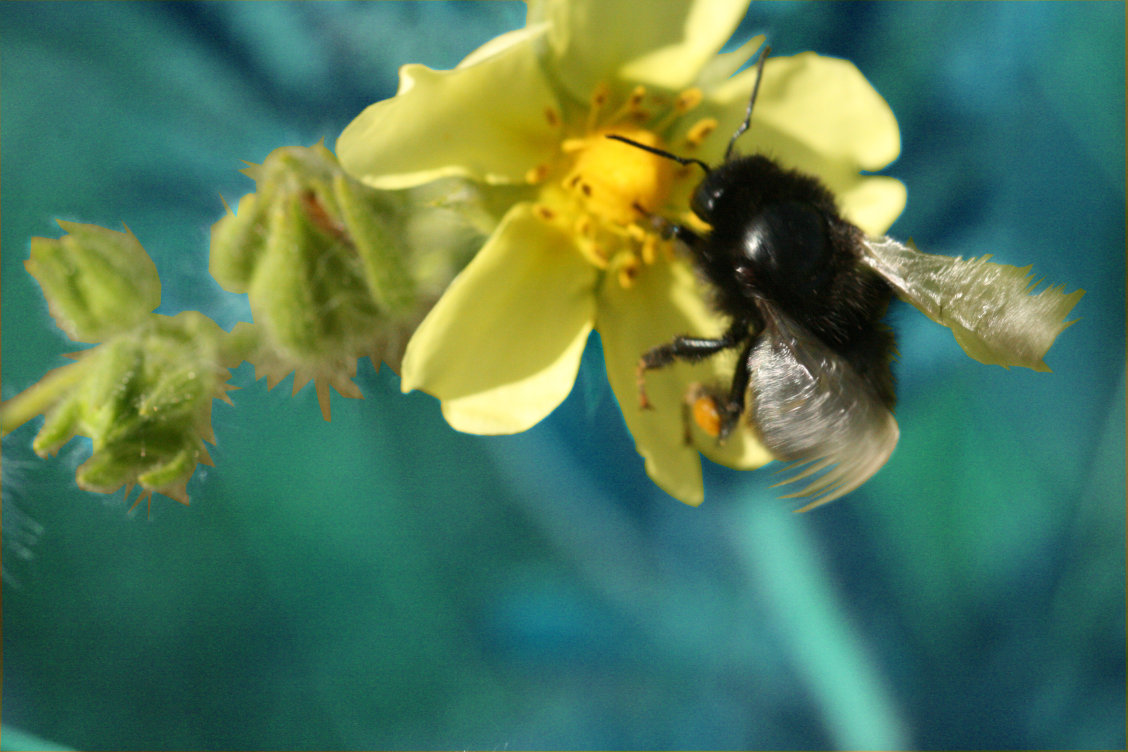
[0,2,1126,750]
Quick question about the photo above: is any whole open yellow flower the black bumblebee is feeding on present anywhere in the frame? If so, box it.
[337,0,905,504]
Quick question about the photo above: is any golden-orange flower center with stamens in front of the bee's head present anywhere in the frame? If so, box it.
[527,87,712,286]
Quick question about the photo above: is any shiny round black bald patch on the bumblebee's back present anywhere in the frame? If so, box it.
[740,201,830,295]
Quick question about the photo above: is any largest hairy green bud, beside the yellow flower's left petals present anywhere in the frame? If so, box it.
[210,144,437,417]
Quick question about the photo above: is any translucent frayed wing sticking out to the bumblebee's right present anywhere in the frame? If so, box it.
[862,237,1085,371]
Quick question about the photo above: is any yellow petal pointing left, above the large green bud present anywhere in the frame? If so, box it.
[336,29,559,188]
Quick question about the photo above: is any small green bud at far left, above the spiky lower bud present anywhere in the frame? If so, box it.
[24,220,160,342]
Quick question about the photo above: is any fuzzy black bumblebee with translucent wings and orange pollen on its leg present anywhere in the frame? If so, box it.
[608,50,1084,510]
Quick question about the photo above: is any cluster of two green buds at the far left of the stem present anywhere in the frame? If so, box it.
[20,222,236,504]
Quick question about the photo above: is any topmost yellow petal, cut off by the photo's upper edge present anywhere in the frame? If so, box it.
[529,0,748,101]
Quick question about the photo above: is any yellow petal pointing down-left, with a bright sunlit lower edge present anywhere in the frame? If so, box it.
[403,204,596,434]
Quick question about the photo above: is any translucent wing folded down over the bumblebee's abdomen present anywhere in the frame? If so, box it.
[749,306,900,512]
